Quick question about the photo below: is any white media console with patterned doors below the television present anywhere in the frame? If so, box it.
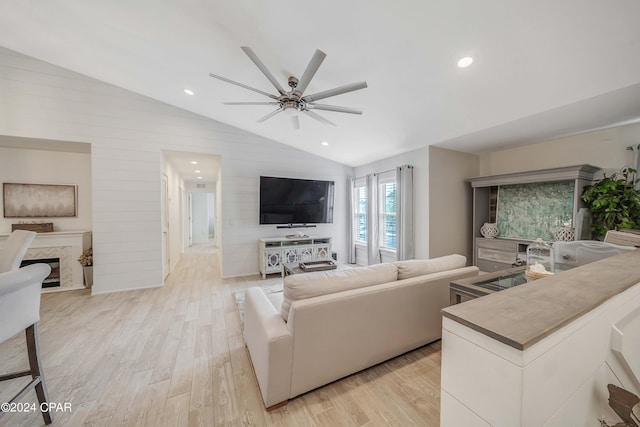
[258,237,331,279]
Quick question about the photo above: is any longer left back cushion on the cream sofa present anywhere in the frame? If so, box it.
[280,263,398,321]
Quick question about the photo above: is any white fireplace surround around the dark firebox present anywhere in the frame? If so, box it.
[0,230,91,292]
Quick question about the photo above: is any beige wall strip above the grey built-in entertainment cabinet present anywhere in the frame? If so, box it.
[479,124,640,176]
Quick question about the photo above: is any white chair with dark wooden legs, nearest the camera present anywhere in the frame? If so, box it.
[0,264,53,424]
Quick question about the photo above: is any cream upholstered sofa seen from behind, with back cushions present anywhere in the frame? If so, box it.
[244,255,478,409]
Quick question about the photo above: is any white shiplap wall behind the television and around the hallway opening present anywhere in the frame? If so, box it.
[0,47,352,293]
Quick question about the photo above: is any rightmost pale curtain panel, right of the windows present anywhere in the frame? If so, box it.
[396,165,414,261]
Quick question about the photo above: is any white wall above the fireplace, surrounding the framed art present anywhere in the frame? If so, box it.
[0,147,92,233]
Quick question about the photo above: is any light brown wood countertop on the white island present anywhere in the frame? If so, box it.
[442,250,640,350]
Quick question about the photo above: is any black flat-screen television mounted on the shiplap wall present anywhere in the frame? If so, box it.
[260,176,334,224]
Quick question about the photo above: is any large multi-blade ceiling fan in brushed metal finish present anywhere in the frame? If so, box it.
[209,46,367,129]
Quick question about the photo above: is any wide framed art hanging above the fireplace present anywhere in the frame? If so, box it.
[2,182,78,218]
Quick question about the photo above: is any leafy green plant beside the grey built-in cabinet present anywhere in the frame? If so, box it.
[581,168,640,240]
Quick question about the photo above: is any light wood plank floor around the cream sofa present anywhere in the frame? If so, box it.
[0,247,440,427]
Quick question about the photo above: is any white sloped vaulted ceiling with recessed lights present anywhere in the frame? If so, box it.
[0,0,640,166]
